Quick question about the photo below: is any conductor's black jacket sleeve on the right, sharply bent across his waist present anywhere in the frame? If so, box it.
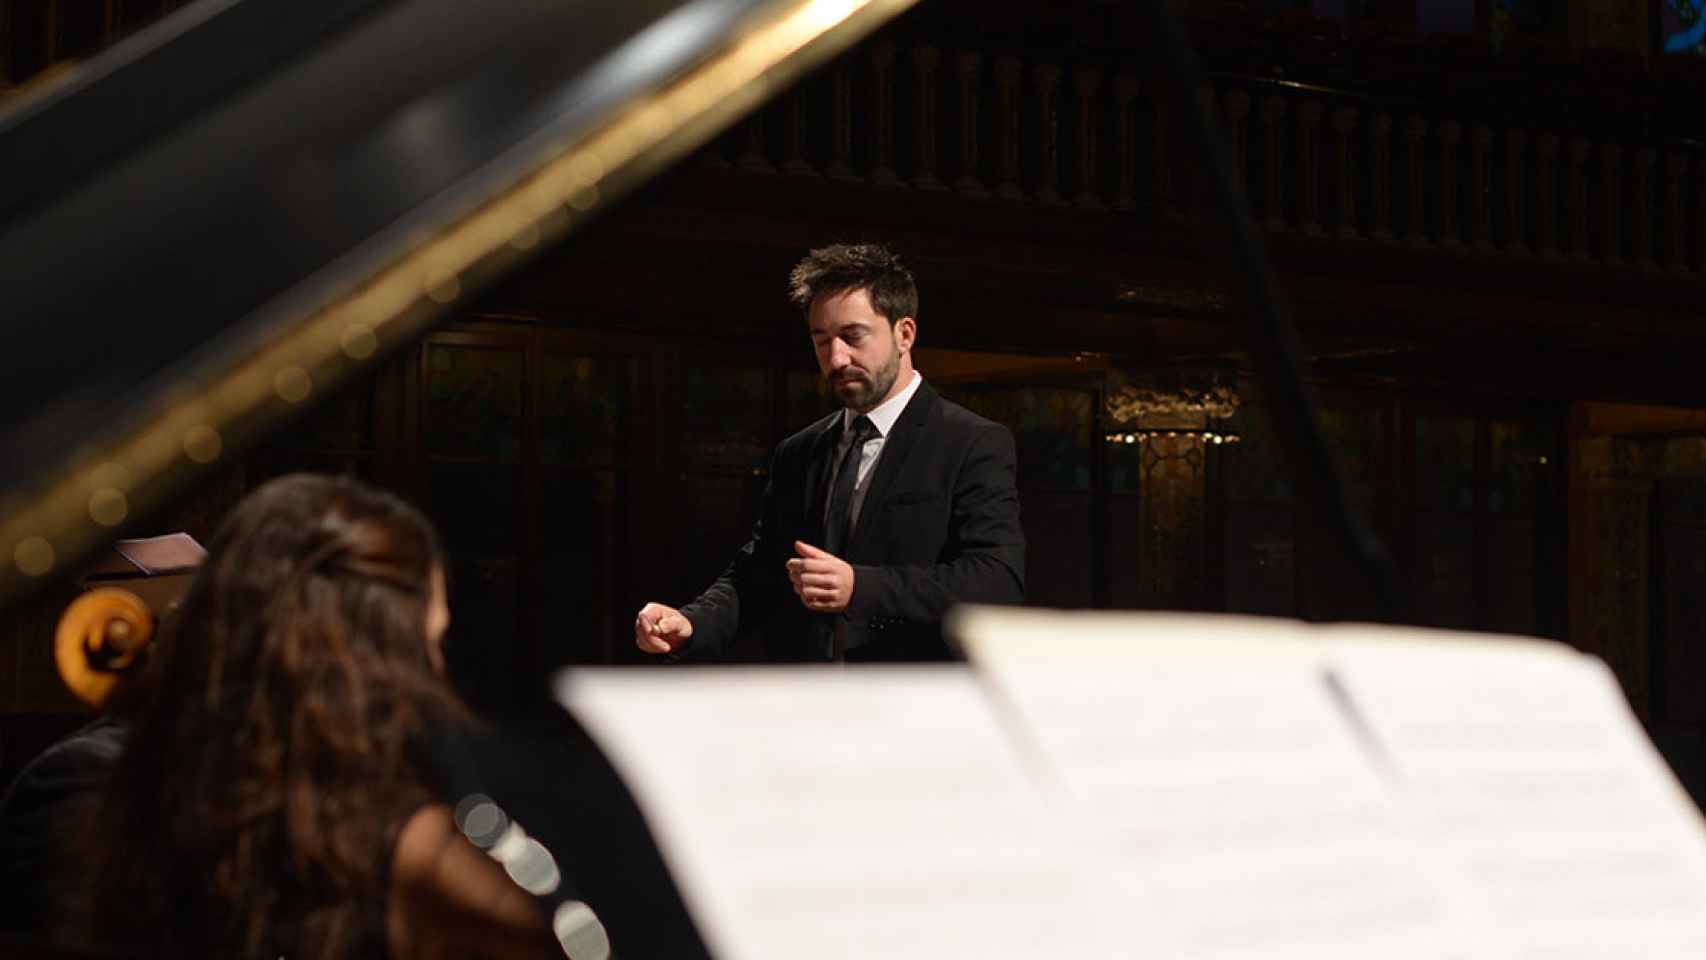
[846,425,1025,622]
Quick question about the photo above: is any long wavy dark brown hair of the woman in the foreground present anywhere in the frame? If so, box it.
[77,474,467,960]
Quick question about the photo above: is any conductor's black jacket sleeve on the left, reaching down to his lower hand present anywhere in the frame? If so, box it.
[681,450,792,658]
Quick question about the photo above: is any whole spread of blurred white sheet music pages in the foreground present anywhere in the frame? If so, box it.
[560,609,1706,960]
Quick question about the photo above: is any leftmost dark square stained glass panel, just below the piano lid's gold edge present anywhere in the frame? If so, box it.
[425,343,524,462]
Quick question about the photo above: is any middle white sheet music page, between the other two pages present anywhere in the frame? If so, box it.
[950,607,1479,960]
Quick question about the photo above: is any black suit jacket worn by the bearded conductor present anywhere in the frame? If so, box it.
[681,384,1025,662]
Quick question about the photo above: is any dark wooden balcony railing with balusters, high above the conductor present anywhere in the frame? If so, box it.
[706,41,1706,275]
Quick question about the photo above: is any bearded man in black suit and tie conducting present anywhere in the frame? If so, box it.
[635,244,1025,662]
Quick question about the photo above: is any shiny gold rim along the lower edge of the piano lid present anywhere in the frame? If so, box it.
[0,0,916,600]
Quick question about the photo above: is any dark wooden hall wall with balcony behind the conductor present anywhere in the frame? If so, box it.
[0,2,1706,791]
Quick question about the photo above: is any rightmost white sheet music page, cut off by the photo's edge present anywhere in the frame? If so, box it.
[1322,626,1706,960]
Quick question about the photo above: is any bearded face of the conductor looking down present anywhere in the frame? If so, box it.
[807,290,918,413]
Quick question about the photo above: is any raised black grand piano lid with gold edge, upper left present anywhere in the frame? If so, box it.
[0,0,913,600]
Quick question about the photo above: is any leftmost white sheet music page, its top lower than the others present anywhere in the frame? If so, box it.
[558,667,1146,960]
